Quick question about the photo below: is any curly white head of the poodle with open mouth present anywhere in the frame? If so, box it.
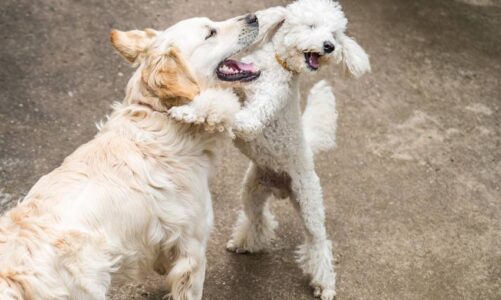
[272,0,370,78]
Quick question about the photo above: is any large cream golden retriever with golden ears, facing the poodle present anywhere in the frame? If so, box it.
[0,14,257,300]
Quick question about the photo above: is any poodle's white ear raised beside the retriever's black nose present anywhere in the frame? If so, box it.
[255,6,287,45]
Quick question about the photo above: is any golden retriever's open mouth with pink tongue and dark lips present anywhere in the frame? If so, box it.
[216,59,261,81]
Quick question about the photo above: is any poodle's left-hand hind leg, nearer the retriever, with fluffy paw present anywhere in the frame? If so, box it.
[226,162,277,253]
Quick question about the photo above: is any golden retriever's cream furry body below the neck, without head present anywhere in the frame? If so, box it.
[0,105,221,299]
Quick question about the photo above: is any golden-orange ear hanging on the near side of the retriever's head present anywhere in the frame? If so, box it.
[142,47,200,103]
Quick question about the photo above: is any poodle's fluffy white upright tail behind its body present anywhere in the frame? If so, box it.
[303,80,337,153]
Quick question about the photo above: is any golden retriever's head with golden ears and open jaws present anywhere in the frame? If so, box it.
[111,15,260,109]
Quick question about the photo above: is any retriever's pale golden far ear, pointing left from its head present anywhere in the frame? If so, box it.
[110,28,158,63]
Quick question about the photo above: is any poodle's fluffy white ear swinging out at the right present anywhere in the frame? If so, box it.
[341,34,371,78]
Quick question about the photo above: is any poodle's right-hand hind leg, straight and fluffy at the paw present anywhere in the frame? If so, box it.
[291,170,336,300]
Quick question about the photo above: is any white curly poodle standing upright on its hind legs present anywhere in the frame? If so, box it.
[227,0,370,300]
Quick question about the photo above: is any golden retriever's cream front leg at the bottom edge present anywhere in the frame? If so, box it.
[164,240,206,300]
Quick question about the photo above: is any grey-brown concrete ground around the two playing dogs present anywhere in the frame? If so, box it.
[0,0,501,300]
